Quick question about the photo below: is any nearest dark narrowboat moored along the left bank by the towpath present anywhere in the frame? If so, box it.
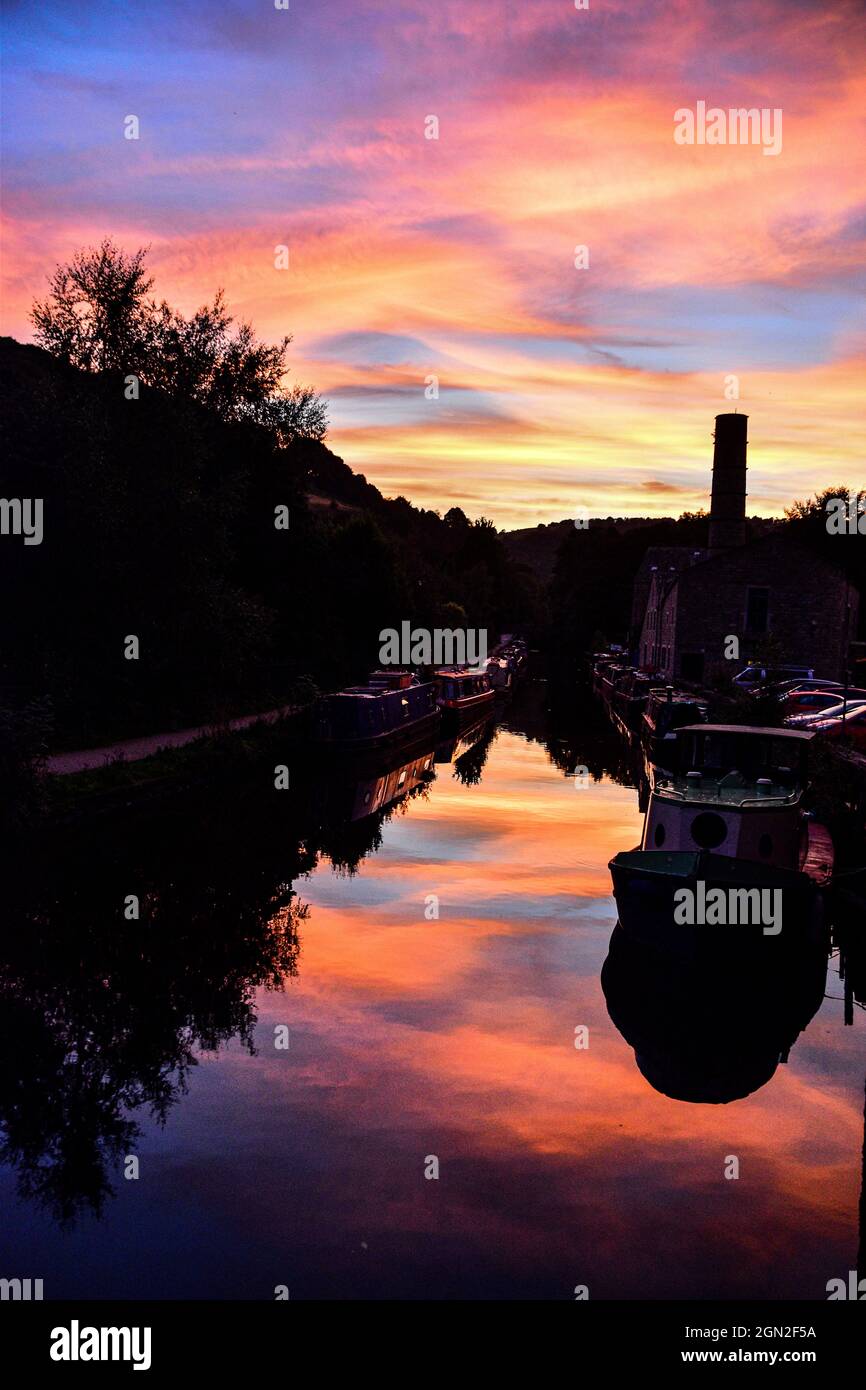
[313,670,439,751]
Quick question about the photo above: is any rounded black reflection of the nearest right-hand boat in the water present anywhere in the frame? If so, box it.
[602,923,827,1105]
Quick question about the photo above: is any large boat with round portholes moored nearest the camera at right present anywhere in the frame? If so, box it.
[609,724,833,947]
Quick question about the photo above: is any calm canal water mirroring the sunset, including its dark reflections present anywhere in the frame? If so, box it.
[0,684,863,1300]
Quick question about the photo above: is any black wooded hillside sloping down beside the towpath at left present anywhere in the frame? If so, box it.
[0,339,532,749]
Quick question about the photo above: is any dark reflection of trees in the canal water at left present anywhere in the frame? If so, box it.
[0,751,432,1226]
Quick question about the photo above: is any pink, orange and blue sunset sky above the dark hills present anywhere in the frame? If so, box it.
[3,0,866,527]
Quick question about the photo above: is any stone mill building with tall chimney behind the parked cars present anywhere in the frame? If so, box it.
[632,414,859,684]
